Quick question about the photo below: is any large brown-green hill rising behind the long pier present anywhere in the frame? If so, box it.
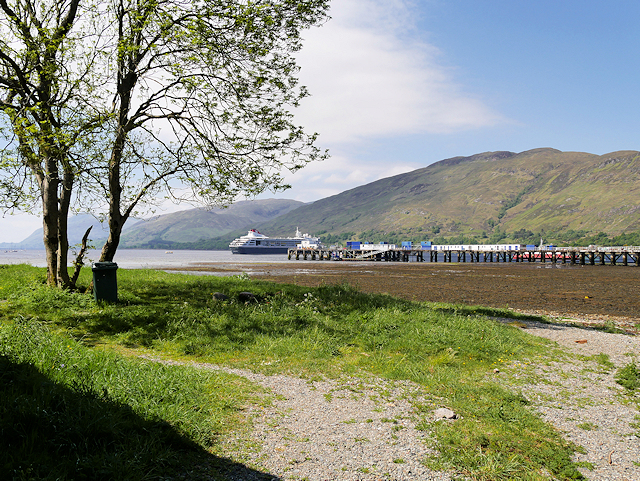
[258,148,640,241]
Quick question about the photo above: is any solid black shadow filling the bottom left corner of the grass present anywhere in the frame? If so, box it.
[0,356,280,481]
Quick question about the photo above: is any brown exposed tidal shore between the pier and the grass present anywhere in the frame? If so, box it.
[176,261,640,330]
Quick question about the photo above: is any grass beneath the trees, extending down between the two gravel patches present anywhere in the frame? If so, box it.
[0,266,581,480]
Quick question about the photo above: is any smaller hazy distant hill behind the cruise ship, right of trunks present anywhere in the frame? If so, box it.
[120,199,304,248]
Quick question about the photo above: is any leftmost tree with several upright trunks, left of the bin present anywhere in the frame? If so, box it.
[0,0,109,286]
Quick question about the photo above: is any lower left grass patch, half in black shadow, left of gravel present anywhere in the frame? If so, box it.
[0,298,264,480]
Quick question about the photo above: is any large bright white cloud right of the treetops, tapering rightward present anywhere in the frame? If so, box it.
[296,0,501,144]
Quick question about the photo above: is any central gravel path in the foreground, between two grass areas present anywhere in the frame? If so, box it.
[218,369,450,481]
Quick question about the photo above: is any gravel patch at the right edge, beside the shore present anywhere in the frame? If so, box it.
[504,319,640,481]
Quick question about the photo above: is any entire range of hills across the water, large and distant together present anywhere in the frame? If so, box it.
[8,148,640,249]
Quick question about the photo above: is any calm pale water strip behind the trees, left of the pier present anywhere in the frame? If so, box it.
[0,249,295,269]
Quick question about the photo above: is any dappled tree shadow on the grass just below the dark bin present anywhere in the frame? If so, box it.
[76,279,390,346]
